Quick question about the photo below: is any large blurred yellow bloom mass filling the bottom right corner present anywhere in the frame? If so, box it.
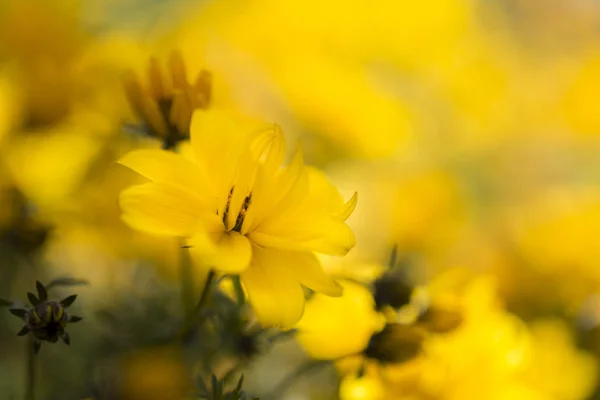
[381,271,596,400]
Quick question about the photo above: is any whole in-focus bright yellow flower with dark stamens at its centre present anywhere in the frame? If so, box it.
[120,111,357,328]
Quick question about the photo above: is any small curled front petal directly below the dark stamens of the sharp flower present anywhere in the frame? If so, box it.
[195,232,252,274]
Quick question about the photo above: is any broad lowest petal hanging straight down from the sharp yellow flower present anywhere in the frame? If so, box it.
[241,246,304,329]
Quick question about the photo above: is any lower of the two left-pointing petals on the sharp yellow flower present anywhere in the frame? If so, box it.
[119,182,206,236]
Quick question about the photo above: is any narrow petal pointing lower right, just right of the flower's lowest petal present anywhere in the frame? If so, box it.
[268,249,343,297]
